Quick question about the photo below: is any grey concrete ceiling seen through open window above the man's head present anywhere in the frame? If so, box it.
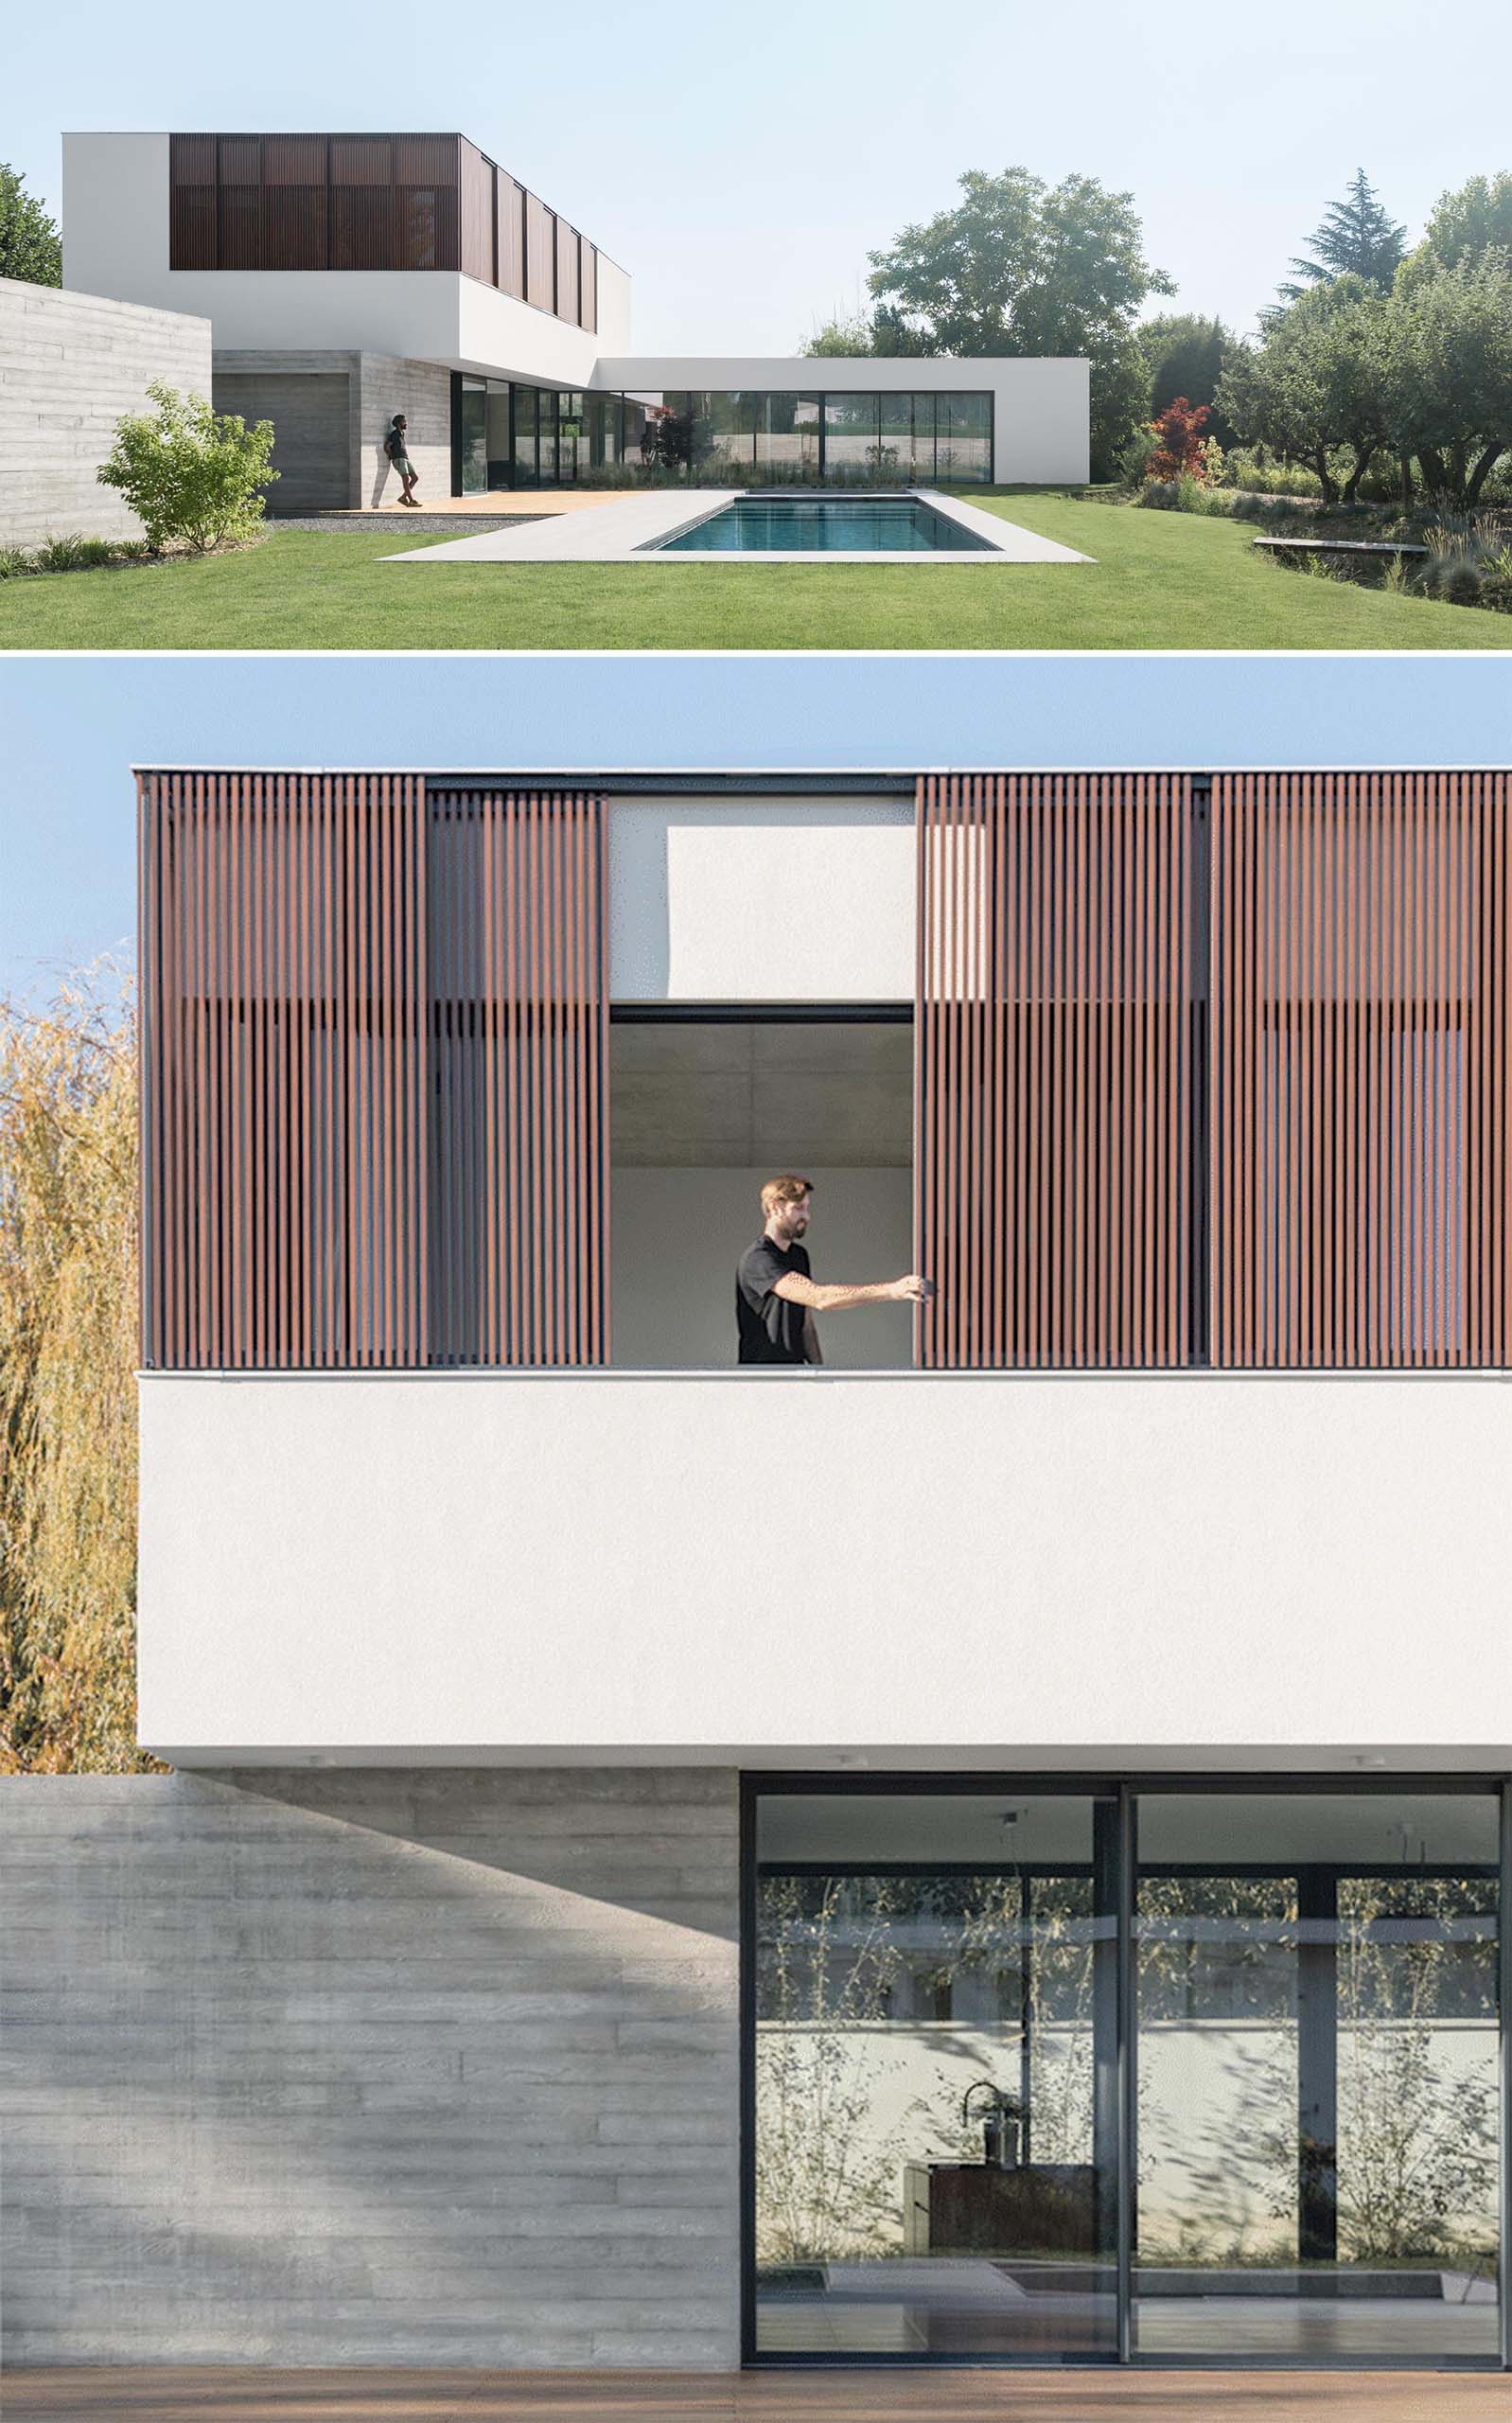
[608,1020,913,1170]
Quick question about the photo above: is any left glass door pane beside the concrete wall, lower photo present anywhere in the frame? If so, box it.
[753,1791,1117,2362]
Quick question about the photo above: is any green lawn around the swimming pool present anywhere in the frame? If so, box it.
[0,492,1512,649]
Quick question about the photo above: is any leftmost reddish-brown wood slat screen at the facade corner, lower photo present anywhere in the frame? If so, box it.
[141,773,427,1369]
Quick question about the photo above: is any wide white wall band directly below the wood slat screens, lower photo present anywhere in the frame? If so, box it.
[141,1366,1512,1769]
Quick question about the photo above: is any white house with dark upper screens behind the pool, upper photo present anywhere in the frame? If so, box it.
[63,133,1090,514]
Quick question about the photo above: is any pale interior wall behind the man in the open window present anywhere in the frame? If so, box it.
[610,1168,913,1371]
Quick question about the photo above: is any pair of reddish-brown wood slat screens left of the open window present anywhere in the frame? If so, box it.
[141,773,608,1369]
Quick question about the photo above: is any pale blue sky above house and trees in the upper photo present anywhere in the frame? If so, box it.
[11,0,1512,354]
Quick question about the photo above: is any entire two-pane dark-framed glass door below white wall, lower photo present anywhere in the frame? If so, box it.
[747,1776,1507,2365]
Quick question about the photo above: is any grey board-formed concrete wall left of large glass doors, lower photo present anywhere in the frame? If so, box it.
[0,1769,739,2367]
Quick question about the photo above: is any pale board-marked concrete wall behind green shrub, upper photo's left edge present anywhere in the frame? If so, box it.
[0,278,211,548]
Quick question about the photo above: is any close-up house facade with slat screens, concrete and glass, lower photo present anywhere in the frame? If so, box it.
[0,766,1512,2370]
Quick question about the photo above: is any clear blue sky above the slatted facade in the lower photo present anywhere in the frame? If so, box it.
[0,654,1512,994]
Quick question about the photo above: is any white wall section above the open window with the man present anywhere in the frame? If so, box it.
[608,797,916,1000]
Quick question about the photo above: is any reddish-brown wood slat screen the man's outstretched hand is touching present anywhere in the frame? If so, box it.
[913,775,1195,1369]
